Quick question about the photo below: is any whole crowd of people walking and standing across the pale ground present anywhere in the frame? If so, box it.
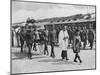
[12,24,95,63]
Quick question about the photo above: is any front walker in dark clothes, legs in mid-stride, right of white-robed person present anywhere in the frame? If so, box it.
[73,30,82,63]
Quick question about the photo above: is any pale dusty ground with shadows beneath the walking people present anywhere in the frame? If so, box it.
[11,44,95,74]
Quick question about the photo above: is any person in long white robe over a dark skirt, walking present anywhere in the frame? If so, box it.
[59,26,69,60]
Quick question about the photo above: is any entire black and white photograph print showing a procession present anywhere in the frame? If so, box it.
[10,0,96,74]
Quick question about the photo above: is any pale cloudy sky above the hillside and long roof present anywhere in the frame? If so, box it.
[11,1,95,23]
